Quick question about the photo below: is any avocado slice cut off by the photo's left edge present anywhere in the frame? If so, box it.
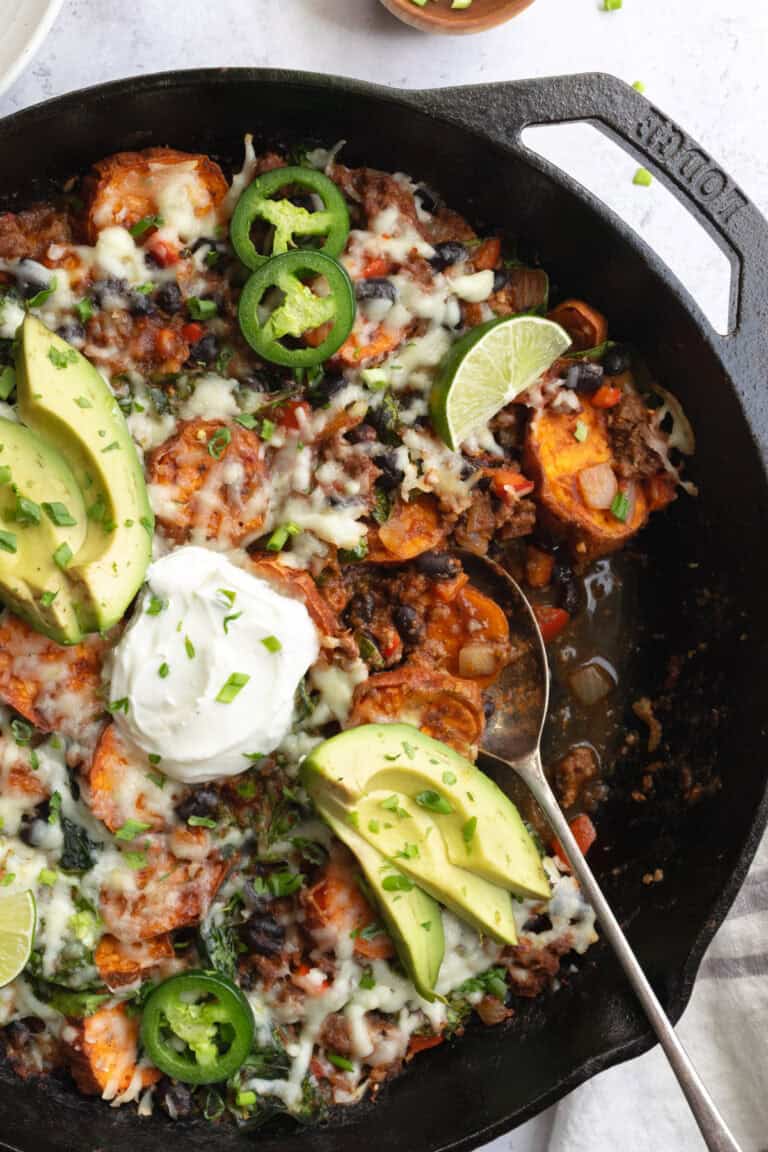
[0,419,88,644]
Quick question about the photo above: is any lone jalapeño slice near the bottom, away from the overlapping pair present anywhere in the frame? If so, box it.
[142,971,253,1084]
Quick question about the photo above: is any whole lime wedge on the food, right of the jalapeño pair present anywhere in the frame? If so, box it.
[429,316,571,450]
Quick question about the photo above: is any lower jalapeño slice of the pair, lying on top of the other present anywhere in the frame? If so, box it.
[238,249,355,367]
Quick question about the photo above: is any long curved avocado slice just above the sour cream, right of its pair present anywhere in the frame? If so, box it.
[16,316,154,631]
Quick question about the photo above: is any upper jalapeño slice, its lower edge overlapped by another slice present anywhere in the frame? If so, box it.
[229,167,349,271]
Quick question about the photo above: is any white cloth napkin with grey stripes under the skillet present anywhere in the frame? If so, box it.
[484,836,768,1152]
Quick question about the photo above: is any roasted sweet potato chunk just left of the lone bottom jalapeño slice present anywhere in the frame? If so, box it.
[64,1005,161,1100]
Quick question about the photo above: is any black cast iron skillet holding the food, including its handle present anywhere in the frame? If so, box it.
[0,69,768,1152]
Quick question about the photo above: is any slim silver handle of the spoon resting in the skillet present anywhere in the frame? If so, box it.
[515,752,740,1152]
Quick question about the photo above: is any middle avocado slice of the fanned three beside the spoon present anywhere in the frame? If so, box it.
[303,770,517,945]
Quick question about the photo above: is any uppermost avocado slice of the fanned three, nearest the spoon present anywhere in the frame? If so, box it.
[305,723,550,900]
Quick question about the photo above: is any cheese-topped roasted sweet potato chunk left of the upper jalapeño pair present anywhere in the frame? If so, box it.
[83,147,227,243]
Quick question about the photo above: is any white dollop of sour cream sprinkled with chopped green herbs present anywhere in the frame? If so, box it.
[111,547,319,783]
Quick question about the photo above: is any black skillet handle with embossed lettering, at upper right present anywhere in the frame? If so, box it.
[416,73,768,380]
